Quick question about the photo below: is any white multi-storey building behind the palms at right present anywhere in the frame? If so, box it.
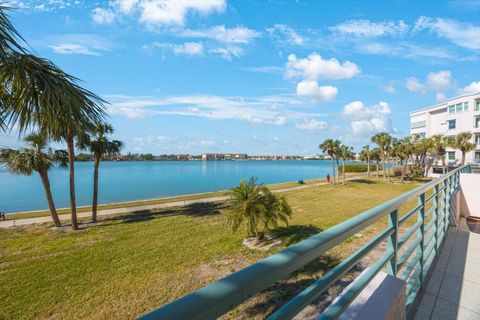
[410,92,480,165]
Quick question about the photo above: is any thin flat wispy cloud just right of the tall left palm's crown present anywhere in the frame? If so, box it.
[41,34,113,56]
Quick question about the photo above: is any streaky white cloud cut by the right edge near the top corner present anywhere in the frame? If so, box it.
[414,16,480,50]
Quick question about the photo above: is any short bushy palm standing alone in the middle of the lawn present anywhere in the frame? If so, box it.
[227,177,292,242]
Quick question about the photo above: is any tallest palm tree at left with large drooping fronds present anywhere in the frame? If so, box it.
[0,21,106,230]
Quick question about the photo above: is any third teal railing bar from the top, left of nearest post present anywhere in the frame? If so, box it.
[317,250,394,320]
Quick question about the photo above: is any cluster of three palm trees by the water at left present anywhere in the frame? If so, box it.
[0,4,122,230]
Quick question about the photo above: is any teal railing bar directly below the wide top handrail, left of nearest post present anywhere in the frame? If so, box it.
[268,228,394,320]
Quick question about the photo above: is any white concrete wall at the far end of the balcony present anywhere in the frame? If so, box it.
[460,173,480,217]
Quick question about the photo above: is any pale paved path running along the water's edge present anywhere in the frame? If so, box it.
[0,176,362,228]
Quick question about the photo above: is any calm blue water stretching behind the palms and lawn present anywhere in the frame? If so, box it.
[0,160,340,212]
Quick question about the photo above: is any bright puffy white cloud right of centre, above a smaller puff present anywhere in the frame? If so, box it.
[286,53,360,80]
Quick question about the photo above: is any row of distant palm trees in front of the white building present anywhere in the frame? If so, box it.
[319,132,476,184]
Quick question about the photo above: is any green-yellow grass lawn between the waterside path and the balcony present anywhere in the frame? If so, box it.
[0,179,418,319]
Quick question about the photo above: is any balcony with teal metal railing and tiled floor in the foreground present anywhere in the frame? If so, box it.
[141,165,480,320]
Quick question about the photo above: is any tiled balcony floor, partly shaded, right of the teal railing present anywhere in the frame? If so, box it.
[415,219,480,320]
